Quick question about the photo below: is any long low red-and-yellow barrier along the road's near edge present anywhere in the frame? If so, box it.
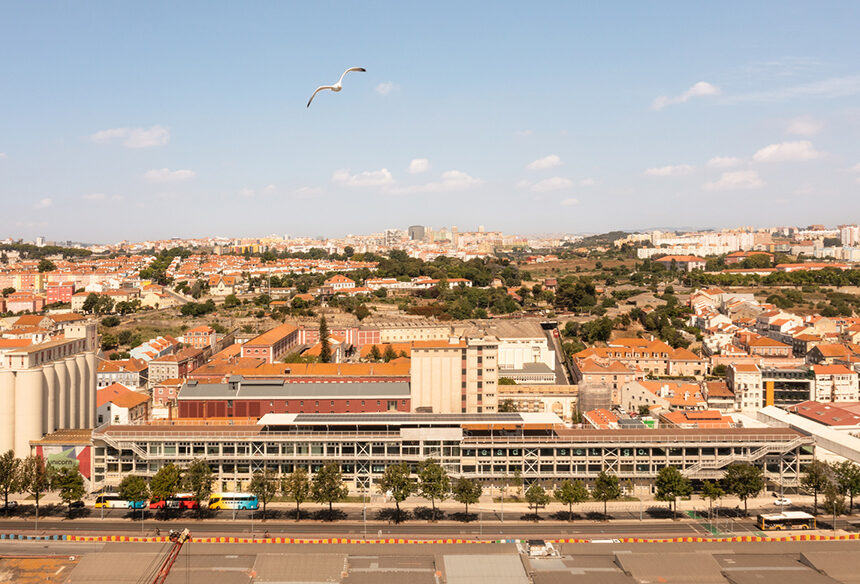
[6,533,860,545]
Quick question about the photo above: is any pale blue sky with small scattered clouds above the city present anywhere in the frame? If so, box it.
[0,0,860,243]
